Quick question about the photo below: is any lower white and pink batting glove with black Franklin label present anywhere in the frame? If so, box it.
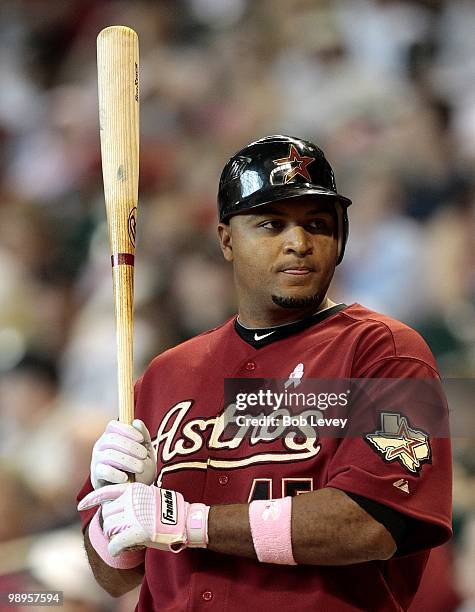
[78,482,209,557]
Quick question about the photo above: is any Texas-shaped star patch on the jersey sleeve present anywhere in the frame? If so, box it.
[365,412,431,473]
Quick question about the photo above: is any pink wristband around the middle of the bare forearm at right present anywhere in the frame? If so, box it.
[249,497,297,565]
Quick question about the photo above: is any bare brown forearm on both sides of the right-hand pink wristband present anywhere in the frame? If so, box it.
[208,487,396,565]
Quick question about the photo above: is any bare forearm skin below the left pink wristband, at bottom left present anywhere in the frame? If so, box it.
[84,530,145,597]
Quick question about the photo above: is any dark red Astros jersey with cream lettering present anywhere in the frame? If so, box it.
[78,304,451,612]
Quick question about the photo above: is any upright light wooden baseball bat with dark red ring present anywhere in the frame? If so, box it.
[97,26,139,423]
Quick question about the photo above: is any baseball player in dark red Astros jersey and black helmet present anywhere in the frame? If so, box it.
[78,136,451,612]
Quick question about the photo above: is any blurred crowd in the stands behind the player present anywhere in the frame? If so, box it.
[0,0,475,612]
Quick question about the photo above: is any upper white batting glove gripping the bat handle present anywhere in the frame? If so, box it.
[91,419,157,489]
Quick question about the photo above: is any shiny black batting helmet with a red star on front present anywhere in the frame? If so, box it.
[218,135,351,264]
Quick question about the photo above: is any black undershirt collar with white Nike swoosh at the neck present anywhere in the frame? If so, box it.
[234,304,347,349]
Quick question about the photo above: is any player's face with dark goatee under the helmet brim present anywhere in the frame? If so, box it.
[218,198,338,326]
